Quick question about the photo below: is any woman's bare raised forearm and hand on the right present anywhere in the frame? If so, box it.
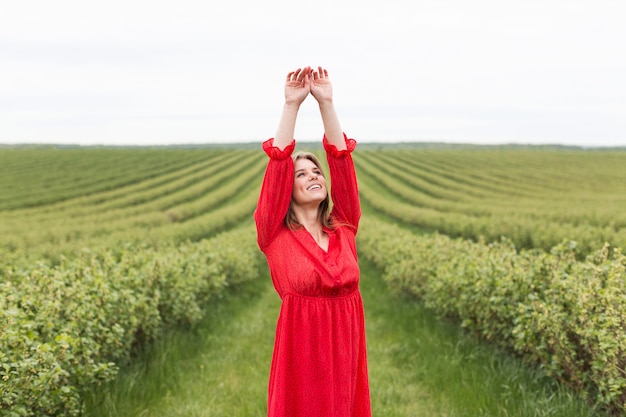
[311,67,346,151]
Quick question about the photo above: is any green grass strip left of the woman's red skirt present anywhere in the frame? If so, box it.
[85,277,280,417]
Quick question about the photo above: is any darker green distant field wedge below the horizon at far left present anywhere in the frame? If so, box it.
[0,147,214,210]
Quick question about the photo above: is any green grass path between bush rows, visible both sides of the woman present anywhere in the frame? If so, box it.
[86,265,597,417]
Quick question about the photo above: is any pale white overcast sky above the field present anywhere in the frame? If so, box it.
[0,0,626,146]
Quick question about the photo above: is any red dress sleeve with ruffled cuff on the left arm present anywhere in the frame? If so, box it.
[254,139,296,250]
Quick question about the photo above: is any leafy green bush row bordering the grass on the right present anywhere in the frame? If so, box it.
[359,220,626,415]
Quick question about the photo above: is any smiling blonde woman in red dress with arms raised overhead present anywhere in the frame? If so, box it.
[254,67,371,417]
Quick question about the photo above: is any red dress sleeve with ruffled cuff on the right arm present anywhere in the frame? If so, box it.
[323,133,361,231]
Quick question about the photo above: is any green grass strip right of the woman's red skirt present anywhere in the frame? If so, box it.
[362,256,604,417]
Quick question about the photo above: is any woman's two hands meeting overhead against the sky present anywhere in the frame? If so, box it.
[285,66,333,105]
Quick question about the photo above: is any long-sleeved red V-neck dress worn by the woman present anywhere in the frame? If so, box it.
[254,135,371,417]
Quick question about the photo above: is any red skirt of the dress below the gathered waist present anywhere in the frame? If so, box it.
[268,290,371,417]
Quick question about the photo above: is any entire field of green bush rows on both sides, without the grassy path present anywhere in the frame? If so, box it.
[0,145,626,416]
